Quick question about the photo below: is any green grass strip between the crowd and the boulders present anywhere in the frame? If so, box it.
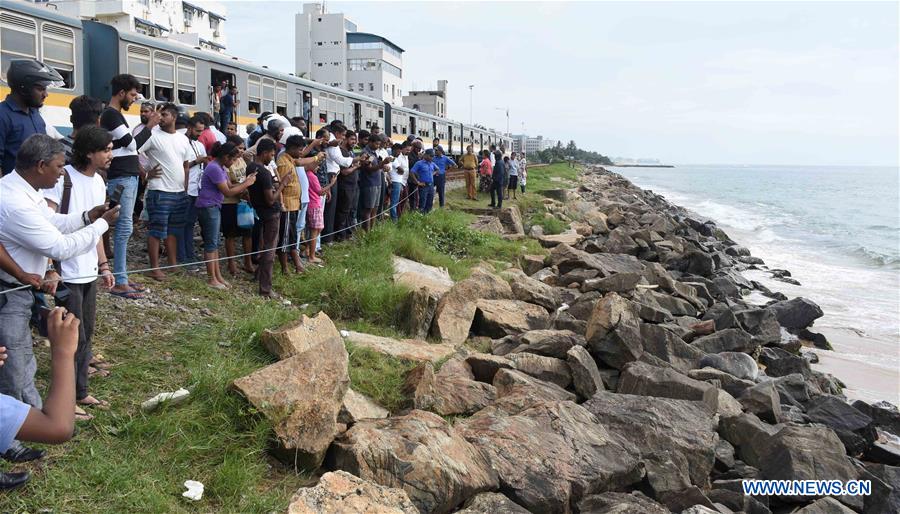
[0,163,576,513]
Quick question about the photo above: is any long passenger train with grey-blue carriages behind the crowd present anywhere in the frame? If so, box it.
[0,0,512,156]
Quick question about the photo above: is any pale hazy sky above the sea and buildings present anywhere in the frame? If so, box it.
[214,0,900,166]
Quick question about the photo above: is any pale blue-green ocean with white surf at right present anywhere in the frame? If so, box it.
[609,165,900,405]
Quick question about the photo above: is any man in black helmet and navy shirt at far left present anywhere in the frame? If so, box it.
[0,59,63,175]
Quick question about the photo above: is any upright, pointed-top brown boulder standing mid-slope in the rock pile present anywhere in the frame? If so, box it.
[585,293,644,369]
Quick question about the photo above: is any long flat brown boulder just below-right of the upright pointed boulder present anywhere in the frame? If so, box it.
[618,362,719,412]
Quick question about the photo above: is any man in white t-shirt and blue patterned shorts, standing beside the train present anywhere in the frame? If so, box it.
[139,104,194,280]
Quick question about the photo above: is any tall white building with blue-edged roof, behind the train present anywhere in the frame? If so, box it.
[295,3,403,104]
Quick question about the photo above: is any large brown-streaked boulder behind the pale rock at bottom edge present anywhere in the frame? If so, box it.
[328,410,498,513]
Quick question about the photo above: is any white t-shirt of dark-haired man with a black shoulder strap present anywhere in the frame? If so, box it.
[43,165,106,284]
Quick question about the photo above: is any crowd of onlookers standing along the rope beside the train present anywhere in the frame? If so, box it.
[0,60,526,489]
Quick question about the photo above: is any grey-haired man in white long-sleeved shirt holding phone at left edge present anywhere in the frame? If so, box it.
[0,134,119,462]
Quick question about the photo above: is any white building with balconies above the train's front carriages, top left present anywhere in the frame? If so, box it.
[46,0,227,52]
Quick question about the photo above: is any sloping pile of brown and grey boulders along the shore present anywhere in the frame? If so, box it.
[235,167,900,514]
